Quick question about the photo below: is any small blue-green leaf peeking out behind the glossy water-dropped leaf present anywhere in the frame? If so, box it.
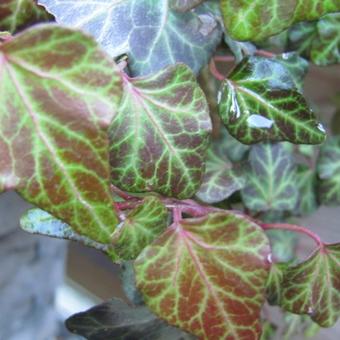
[275,52,309,93]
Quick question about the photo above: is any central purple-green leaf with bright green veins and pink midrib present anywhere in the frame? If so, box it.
[110,64,211,198]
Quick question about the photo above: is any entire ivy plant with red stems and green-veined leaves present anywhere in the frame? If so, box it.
[0,0,340,340]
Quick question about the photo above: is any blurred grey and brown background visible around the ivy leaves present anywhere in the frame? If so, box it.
[0,66,340,340]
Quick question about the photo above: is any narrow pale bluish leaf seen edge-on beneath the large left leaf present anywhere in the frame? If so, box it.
[20,209,117,259]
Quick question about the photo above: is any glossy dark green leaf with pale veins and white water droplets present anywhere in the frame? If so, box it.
[219,57,325,144]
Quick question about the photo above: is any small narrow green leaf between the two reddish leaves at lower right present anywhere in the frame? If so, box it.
[266,263,288,305]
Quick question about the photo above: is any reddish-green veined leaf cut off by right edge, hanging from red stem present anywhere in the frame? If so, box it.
[281,244,340,327]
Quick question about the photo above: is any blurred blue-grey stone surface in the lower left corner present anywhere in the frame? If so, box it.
[0,193,66,340]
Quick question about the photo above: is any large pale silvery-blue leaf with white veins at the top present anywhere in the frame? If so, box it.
[39,0,222,76]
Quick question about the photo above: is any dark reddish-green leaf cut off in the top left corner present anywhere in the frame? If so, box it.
[0,0,53,33]
